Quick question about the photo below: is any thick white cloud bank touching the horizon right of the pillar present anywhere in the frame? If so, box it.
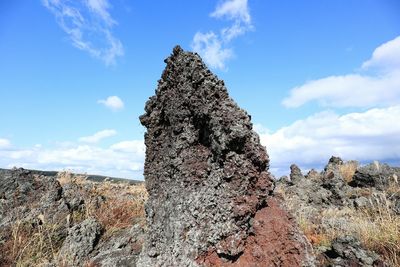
[258,105,400,177]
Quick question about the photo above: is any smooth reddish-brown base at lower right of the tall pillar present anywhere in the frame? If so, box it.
[197,197,312,267]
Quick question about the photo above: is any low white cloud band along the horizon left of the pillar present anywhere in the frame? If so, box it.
[0,140,145,179]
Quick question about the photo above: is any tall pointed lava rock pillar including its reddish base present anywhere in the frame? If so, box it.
[137,46,312,266]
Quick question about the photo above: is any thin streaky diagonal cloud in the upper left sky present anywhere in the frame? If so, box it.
[42,0,124,65]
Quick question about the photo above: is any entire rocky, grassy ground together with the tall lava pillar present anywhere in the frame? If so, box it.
[0,47,400,267]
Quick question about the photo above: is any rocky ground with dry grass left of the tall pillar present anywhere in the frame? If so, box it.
[0,169,147,267]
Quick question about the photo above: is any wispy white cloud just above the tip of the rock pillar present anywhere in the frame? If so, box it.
[192,0,253,69]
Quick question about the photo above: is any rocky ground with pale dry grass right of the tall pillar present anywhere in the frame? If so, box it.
[275,157,400,266]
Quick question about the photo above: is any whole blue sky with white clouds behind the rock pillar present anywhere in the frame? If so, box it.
[0,0,400,179]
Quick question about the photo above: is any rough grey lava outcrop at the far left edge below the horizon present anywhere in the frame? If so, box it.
[0,169,69,234]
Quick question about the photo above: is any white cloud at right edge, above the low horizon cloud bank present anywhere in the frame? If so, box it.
[282,37,400,108]
